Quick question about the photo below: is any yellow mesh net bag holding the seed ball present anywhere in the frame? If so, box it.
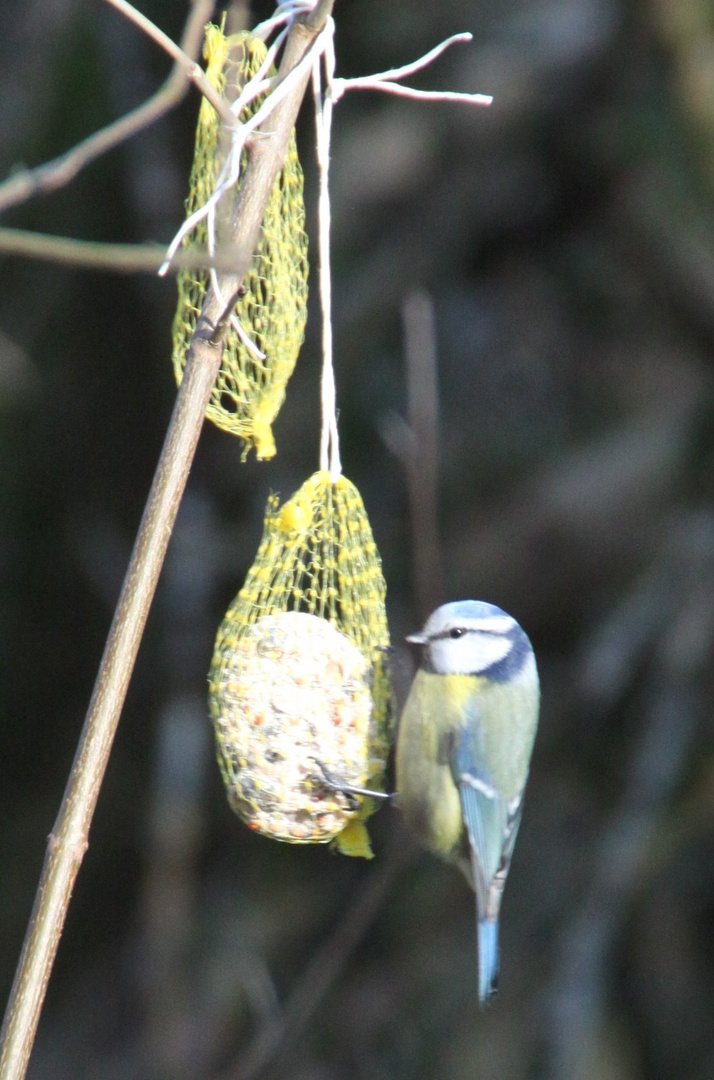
[210,470,391,858]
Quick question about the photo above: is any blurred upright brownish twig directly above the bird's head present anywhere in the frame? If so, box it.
[382,292,444,618]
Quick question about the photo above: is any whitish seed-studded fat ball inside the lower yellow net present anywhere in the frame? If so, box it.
[211,611,383,843]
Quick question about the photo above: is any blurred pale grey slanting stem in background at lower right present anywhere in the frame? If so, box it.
[549,515,714,1080]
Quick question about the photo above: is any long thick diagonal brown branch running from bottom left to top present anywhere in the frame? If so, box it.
[0,8,330,1080]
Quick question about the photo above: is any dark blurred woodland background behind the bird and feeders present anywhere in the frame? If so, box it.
[0,0,714,1080]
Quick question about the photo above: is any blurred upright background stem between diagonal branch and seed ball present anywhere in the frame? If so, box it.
[137,490,218,1080]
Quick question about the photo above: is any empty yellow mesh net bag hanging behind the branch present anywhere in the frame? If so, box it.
[173,25,308,458]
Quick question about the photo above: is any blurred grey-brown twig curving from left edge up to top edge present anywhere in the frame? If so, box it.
[0,0,214,213]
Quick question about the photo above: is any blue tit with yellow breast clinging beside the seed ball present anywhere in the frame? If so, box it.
[395,600,540,1003]
